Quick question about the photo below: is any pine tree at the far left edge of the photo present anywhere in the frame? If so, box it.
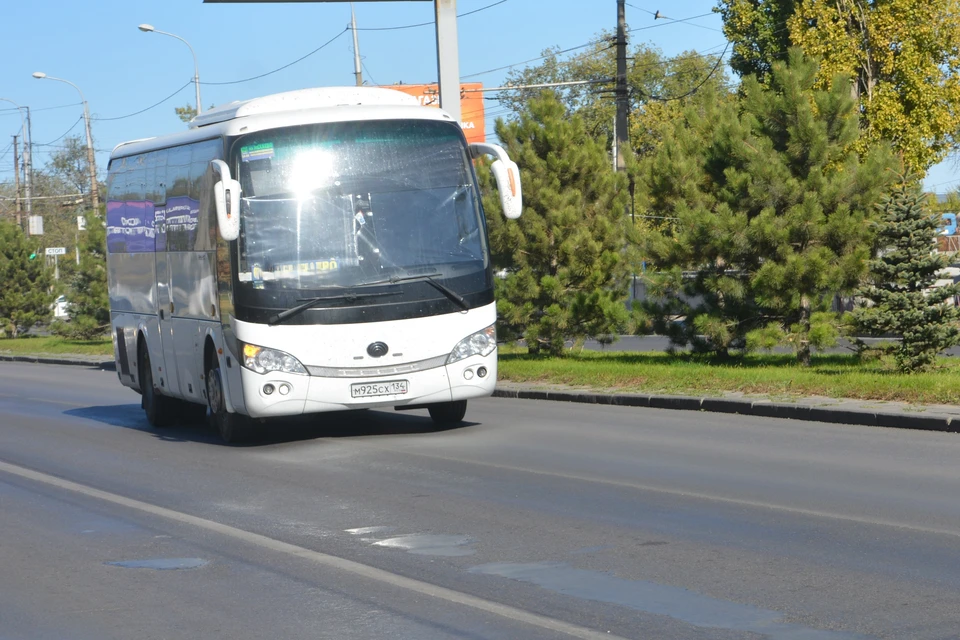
[0,222,53,338]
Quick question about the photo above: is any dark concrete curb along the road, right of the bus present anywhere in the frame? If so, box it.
[493,389,960,433]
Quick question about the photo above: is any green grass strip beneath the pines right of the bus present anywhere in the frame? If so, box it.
[499,349,960,404]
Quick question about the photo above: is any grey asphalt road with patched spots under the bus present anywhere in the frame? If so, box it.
[0,364,960,640]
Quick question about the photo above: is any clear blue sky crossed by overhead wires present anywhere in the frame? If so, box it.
[0,0,960,191]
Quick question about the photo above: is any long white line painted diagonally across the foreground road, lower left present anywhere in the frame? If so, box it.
[0,462,625,640]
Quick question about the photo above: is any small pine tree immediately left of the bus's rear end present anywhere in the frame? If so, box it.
[52,212,110,340]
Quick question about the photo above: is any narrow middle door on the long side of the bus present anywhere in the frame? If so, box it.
[147,152,181,397]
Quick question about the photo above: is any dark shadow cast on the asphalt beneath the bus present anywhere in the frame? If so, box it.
[64,404,479,447]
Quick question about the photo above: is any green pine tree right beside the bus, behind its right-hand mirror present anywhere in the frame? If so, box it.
[481,92,629,354]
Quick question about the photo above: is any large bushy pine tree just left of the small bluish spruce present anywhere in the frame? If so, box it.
[641,50,893,364]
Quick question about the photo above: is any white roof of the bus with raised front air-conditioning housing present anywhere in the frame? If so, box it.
[110,87,453,158]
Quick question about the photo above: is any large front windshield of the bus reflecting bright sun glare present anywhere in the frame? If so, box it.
[231,120,488,289]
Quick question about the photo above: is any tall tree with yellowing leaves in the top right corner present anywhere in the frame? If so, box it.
[718,0,960,174]
